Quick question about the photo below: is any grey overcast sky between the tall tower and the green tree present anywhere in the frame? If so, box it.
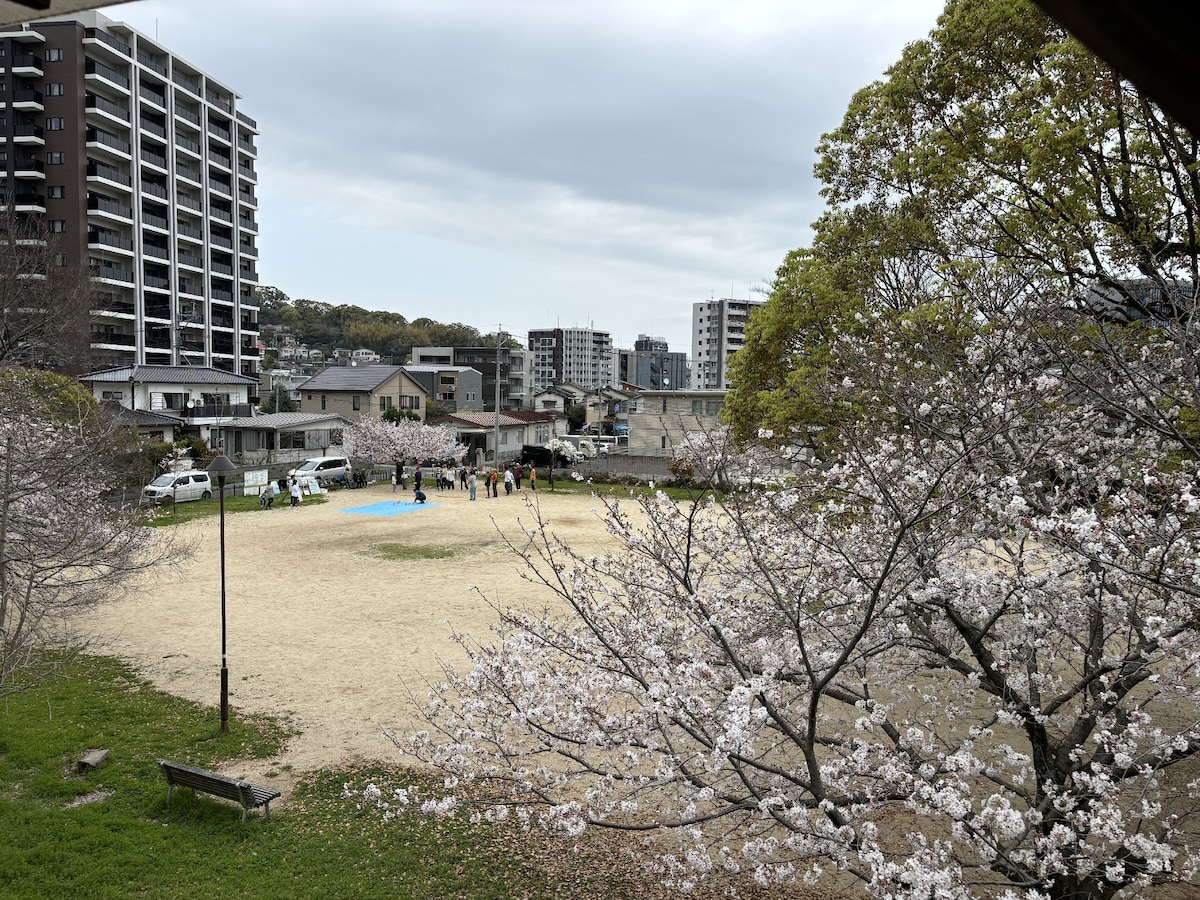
[102,0,942,354]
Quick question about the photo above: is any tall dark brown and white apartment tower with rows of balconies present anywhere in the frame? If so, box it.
[0,12,259,376]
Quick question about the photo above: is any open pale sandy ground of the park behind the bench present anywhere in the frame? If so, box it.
[90,484,605,787]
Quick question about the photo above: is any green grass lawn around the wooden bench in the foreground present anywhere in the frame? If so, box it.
[0,657,644,900]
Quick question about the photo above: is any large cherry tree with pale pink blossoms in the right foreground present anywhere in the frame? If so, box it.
[350,298,1200,899]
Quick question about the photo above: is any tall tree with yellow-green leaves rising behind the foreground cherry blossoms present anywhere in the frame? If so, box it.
[728,0,1200,451]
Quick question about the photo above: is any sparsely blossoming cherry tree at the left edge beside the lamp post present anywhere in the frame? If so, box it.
[0,371,179,696]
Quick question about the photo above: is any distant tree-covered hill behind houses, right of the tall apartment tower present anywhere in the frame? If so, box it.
[257,286,496,362]
